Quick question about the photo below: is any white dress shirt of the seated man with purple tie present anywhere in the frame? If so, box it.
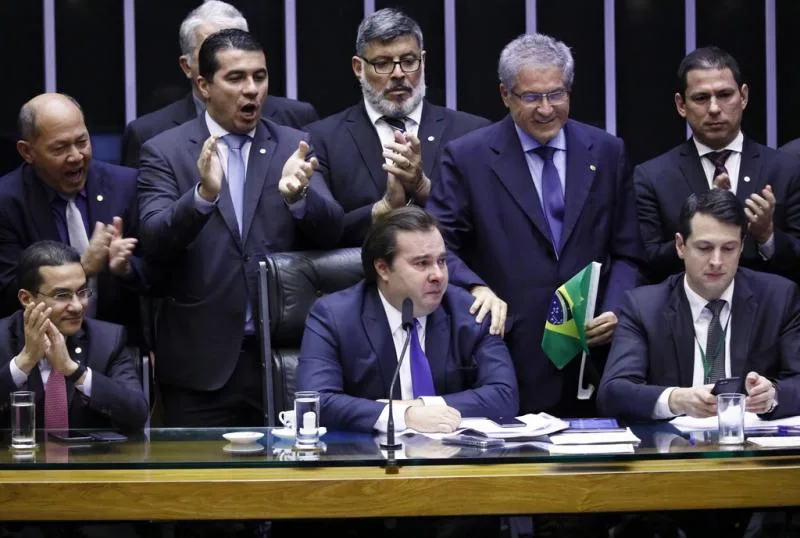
[375,290,447,432]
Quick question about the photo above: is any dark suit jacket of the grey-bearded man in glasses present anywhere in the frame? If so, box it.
[306,101,489,246]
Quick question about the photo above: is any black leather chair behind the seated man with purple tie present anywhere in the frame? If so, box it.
[259,248,363,426]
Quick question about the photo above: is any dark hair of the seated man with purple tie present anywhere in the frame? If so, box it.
[361,206,439,282]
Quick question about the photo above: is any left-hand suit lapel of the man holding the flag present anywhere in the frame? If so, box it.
[489,116,552,241]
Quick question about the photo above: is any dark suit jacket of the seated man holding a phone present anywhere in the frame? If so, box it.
[598,269,800,420]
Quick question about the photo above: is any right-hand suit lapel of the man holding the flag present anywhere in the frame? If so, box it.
[559,122,597,250]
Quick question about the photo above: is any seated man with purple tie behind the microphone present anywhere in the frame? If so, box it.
[297,207,518,432]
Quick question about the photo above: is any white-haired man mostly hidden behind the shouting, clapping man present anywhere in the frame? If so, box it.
[121,0,319,168]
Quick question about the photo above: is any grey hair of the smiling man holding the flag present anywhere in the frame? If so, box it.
[497,34,575,90]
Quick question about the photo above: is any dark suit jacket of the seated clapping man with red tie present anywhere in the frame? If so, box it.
[0,310,148,429]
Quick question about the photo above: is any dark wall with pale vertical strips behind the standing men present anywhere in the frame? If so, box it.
[0,0,800,174]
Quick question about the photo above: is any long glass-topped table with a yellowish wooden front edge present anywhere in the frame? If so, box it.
[0,426,800,520]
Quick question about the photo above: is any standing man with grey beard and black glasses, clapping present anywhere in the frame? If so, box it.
[306,8,489,246]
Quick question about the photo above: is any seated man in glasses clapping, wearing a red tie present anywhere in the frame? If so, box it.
[0,241,148,430]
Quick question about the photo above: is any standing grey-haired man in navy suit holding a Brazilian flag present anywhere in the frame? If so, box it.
[428,34,641,416]
